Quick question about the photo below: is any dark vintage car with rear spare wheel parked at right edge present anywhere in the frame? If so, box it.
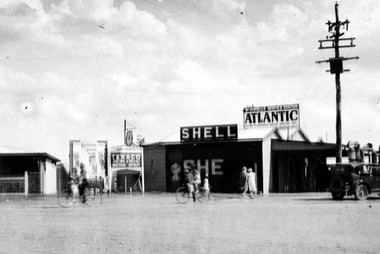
[328,162,380,200]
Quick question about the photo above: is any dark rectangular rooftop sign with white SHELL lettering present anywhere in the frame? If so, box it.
[181,124,238,142]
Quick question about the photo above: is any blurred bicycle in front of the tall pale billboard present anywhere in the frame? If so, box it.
[57,183,104,208]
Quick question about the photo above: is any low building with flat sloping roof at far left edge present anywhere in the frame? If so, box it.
[0,146,60,194]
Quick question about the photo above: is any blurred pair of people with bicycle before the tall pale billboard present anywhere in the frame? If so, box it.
[69,163,88,203]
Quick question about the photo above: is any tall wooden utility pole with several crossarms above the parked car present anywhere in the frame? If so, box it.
[316,3,359,163]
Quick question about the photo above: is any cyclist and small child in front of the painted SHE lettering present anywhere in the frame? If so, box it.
[184,164,210,202]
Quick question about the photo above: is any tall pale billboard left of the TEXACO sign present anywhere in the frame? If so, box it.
[70,140,107,179]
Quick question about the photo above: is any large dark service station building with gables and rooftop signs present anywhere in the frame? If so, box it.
[144,104,335,194]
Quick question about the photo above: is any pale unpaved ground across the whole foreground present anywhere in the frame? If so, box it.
[0,193,380,253]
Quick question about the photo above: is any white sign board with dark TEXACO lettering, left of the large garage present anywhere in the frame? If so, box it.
[110,146,143,172]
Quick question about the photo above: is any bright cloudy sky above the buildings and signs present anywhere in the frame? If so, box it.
[0,0,380,166]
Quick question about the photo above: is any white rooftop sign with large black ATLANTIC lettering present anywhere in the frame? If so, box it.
[243,104,300,127]
